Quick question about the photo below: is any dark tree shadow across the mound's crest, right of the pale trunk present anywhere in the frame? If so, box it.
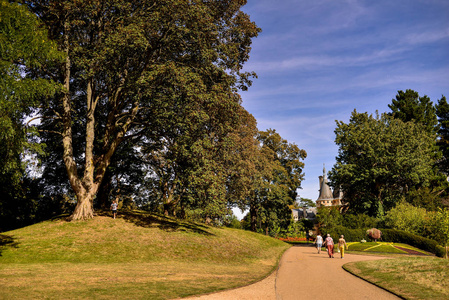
[98,211,214,236]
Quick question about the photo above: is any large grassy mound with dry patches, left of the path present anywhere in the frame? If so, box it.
[0,212,288,299]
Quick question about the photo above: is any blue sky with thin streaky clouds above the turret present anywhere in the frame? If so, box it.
[234,0,449,211]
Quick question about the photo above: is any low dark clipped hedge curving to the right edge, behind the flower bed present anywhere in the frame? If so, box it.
[381,229,445,257]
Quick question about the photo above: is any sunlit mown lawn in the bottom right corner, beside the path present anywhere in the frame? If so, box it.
[343,256,449,300]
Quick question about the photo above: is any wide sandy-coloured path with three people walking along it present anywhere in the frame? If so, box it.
[189,246,399,300]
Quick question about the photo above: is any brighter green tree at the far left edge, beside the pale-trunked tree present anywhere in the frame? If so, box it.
[0,0,63,231]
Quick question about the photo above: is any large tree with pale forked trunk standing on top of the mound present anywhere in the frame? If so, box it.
[24,0,259,220]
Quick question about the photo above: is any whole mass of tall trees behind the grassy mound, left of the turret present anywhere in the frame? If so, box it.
[0,0,306,233]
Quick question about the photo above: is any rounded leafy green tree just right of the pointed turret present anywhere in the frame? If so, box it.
[329,110,436,217]
